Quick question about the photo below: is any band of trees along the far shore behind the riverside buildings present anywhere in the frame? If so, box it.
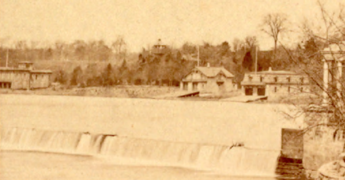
[0,10,328,87]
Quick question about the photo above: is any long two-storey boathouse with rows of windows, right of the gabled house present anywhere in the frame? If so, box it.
[241,68,310,96]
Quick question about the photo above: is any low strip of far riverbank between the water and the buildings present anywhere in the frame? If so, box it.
[0,85,321,106]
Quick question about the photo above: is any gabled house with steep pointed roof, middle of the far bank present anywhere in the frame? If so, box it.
[180,65,234,94]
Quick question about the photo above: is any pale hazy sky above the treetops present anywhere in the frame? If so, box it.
[0,0,344,51]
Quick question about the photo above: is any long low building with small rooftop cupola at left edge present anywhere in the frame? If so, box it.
[0,62,52,90]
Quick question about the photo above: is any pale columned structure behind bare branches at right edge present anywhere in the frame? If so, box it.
[322,42,345,106]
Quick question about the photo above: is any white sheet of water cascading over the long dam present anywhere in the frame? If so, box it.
[0,128,280,176]
